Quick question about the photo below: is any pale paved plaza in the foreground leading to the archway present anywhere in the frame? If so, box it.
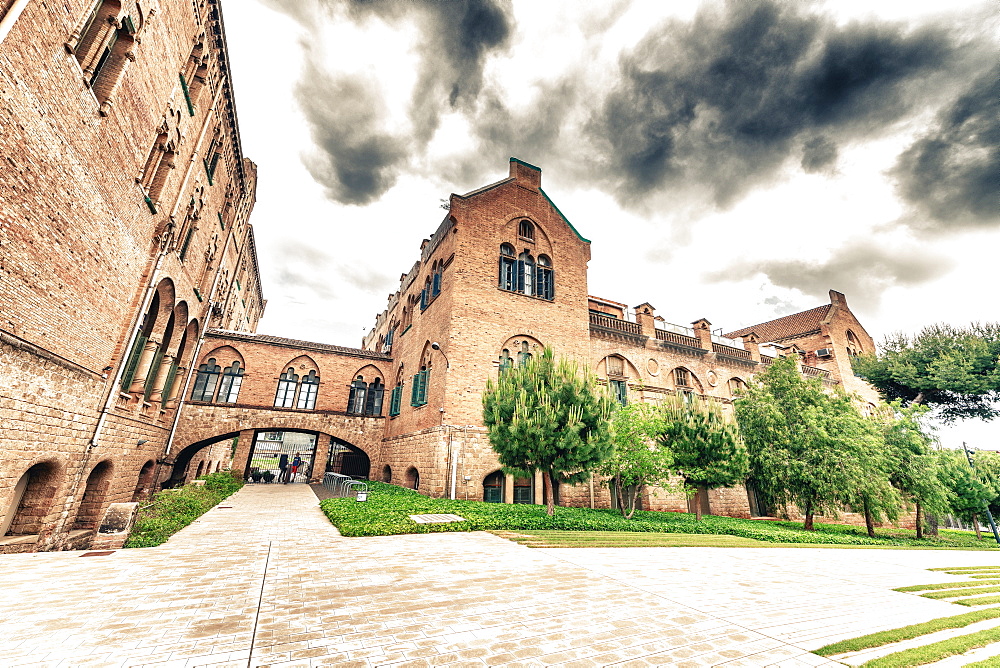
[0,485,1000,668]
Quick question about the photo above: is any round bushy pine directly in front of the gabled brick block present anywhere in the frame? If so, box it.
[483,348,614,515]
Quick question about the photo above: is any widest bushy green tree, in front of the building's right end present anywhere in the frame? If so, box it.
[736,358,889,531]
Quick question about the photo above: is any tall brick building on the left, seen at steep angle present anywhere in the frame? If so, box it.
[0,0,264,551]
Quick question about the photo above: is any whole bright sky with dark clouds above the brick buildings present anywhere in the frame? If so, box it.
[225,0,1000,449]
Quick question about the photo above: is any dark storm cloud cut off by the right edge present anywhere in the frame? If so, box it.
[893,67,1000,231]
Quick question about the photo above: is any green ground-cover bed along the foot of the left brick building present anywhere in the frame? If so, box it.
[125,471,243,547]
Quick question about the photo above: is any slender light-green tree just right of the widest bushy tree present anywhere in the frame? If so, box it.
[877,400,950,538]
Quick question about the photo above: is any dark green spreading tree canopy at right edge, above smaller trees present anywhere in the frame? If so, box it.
[852,323,1000,422]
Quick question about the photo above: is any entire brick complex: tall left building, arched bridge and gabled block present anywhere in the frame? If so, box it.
[0,0,875,552]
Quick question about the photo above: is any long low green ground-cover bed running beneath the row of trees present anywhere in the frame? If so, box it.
[320,482,988,548]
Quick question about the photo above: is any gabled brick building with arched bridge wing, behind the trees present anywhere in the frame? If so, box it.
[176,159,876,516]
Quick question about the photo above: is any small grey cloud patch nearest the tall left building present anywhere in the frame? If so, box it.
[295,50,409,204]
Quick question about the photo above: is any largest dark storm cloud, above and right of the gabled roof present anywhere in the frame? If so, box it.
[588,1,956,206]
